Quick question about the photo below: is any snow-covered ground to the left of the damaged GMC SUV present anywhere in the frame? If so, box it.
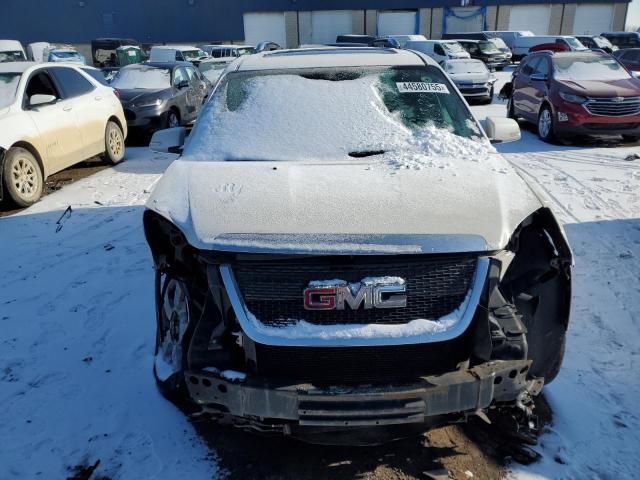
[0,148,219,480]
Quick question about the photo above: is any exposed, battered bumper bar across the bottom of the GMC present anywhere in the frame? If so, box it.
[185,360,543,434]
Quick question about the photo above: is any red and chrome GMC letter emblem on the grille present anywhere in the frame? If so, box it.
[304,279,407,310]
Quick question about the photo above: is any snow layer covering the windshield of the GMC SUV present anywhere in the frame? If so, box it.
[185,75,492,167]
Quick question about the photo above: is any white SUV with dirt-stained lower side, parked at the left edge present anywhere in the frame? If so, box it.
[0,62,127,207]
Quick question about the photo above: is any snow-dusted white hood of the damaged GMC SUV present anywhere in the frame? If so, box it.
[147,154,541,253]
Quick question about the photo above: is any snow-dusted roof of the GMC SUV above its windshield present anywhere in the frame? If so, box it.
[238,47,435,71]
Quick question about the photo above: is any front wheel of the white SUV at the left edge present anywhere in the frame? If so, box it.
[2,147,44,207]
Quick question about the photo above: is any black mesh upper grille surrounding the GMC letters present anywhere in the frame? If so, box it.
[234,254,477,326]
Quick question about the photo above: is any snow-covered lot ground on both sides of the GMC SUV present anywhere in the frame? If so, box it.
[0,74,640,480]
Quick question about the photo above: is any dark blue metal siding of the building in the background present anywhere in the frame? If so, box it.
[0,0,628,43]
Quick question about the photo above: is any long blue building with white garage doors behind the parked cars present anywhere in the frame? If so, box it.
[0,0,628,47]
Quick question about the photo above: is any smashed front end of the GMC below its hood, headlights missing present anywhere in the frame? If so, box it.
[145,208,572,443]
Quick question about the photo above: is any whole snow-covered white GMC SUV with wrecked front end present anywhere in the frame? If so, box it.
[144,48,572,442]
